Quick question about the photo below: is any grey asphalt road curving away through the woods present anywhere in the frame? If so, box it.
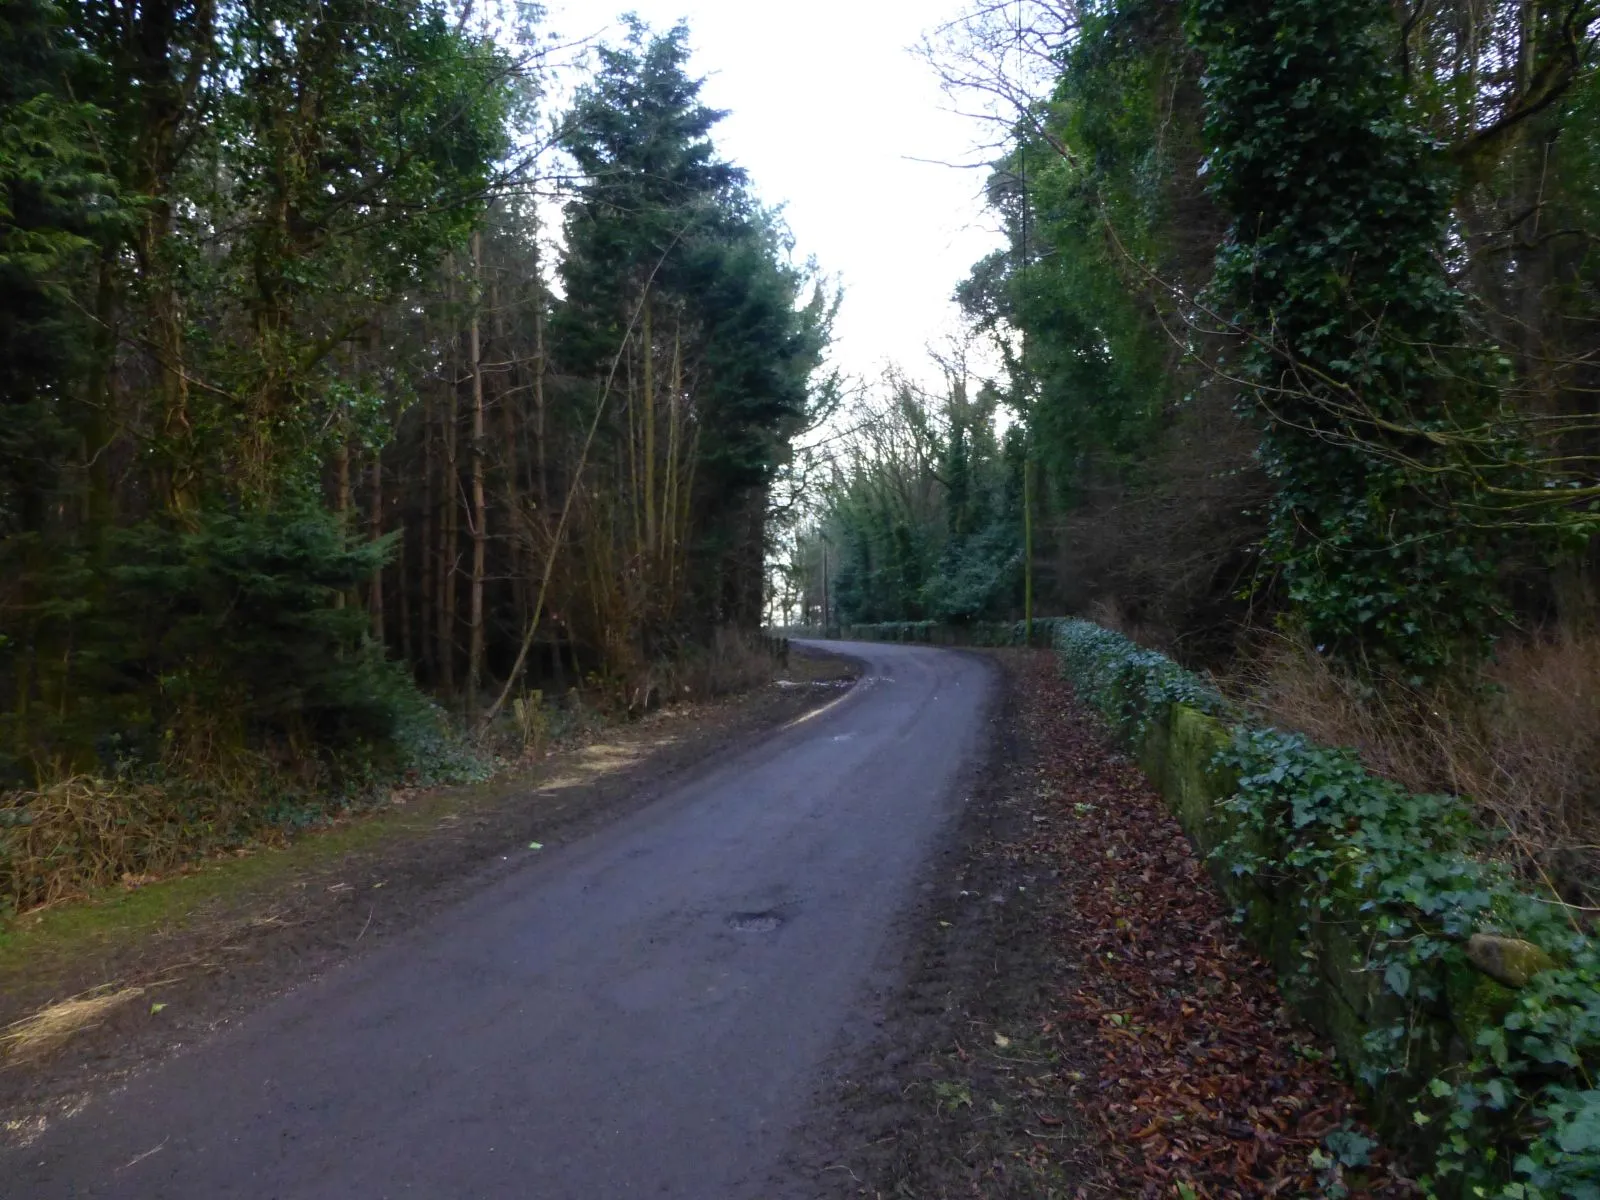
[9,643,992,1200]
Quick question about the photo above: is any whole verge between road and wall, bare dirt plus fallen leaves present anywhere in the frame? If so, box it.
[786,650,1416,1200]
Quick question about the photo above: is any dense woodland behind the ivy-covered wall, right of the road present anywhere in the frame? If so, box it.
[789,0,1600,896]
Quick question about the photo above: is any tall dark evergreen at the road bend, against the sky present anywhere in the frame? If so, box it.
[554,21,832,642]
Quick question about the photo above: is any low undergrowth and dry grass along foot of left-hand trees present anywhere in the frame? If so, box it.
[0,630,787,920]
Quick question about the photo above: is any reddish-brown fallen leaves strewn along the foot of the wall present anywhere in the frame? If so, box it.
[1005,653,1416,1200]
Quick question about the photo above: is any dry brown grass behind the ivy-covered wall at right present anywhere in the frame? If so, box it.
[1235,632,1600,906]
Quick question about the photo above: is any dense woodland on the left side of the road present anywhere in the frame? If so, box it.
[0,0,834,904]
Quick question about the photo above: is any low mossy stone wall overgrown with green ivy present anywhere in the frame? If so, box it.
[838,618,1600,1200]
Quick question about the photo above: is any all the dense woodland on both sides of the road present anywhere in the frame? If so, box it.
[0,0,1600,896]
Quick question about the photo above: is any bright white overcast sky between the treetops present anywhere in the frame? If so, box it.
[547,0,1002,379]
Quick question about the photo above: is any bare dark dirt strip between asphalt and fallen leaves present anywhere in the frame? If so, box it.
[782,651,1088,1200]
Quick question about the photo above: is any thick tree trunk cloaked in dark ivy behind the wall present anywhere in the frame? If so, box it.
[1189,0,1498,674]
